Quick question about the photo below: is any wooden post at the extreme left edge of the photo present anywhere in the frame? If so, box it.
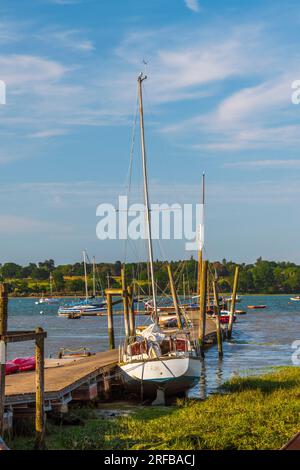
[0,284,8,437]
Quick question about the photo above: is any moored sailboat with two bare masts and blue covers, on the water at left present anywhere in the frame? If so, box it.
[57,250,106,318]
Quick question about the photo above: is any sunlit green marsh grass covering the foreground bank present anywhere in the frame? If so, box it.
[11,367,300,450]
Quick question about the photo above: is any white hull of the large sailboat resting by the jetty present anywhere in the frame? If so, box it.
[119,357,201,397]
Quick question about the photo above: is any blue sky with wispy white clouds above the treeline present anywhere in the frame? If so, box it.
[0,0,300,264]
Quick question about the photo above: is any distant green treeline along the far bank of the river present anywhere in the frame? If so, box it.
[0,257,300,295]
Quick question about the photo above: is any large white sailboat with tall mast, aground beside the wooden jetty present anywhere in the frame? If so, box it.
[119,73,200,403]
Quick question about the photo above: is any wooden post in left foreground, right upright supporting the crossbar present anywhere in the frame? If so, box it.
[35,328,45,450]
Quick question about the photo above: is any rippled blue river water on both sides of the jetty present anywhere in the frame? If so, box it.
[8,295,300,397]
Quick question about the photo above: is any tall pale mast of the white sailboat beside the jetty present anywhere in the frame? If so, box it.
[138,73,158,323]
